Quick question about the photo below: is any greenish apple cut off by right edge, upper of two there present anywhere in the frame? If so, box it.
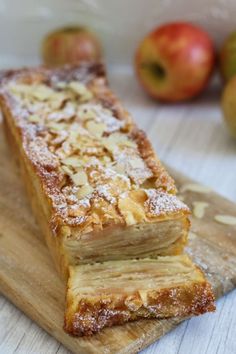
[220,32,236,81]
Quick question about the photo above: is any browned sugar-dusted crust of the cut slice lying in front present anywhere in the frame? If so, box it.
[64,282,215,336]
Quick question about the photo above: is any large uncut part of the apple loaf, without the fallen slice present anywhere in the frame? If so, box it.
[0,64,189,275]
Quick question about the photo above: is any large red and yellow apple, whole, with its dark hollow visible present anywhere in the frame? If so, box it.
[135,22,215,102]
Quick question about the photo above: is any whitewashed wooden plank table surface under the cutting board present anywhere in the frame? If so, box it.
[0,70,236,354]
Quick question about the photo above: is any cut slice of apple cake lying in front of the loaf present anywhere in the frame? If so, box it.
[65,255,215,336]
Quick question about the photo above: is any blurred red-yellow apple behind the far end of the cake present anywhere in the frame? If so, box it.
[42,26,101,66]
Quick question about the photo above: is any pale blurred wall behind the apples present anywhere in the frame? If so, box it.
[0,0,236,66]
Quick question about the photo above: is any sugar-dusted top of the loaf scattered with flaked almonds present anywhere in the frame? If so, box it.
[0,63,188,232]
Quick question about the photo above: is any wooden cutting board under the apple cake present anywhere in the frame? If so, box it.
[0,121,236,354]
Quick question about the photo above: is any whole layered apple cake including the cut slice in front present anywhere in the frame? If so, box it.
[0,63,214,335]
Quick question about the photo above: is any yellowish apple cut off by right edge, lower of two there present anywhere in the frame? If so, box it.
[222,76,236,138]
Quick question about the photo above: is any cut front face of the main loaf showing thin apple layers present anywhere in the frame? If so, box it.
[64,217,188,264]
